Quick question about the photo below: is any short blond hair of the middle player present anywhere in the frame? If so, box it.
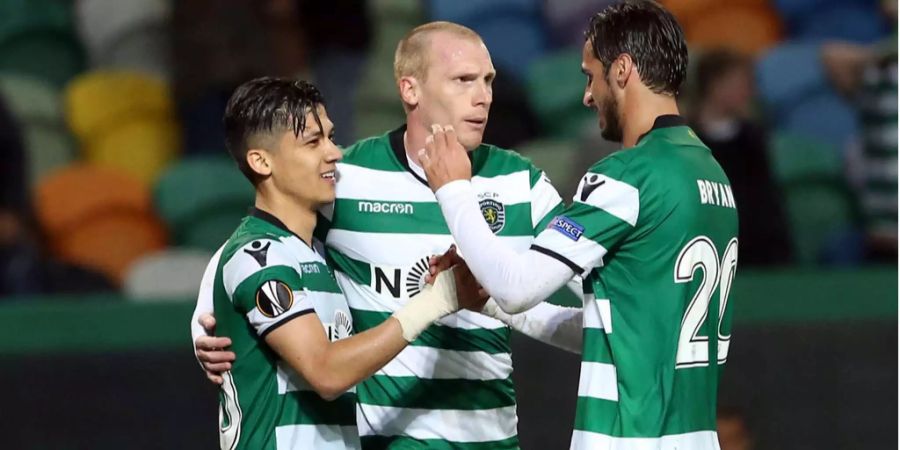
[394,22,481,81]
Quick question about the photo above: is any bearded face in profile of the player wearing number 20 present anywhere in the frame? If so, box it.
[581,41,622,142]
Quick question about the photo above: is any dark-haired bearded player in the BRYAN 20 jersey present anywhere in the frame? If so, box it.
[422,1,738,450]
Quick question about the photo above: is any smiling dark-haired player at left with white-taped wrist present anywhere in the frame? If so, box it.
[211,78,475,450]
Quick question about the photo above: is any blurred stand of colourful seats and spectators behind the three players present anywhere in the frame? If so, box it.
[0,0,897,300]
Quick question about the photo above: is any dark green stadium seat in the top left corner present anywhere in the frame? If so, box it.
[0,0,84,87]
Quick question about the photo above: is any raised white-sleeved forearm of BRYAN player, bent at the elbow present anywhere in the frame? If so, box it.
[435,181,573,314]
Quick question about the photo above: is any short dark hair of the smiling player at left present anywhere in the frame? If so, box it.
[222,77,325,185]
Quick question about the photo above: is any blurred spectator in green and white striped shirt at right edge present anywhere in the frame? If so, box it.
[822,0,897,263]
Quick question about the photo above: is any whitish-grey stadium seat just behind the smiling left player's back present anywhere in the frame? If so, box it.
[123,248,212,302]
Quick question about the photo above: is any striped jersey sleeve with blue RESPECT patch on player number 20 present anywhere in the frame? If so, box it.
[532,158,640,276]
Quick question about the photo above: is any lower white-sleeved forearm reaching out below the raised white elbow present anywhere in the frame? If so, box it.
[482,299,583,353]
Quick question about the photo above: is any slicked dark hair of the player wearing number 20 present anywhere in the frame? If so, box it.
[584,0,688,96]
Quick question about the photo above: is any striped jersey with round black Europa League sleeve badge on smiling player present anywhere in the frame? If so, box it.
[213,210,360,450]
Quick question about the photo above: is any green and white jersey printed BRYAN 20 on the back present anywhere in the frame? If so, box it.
[535,116,738,450]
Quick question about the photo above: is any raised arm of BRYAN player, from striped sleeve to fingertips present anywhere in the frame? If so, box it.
[420,128,638,314]
